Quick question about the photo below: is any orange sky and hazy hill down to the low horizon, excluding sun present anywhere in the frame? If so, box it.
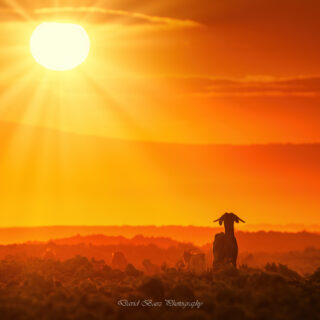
[0,0,320,226]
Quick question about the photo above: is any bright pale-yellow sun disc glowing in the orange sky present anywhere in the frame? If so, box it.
[30,22,90,71]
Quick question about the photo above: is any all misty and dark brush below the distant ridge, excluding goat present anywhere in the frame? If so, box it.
[0,231,320,320]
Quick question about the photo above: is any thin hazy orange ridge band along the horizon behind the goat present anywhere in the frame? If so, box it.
[0,226,320,252]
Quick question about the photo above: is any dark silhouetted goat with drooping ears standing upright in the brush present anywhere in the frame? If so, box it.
[213,212,244,270]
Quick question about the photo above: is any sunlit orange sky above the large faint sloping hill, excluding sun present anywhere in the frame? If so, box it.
[0,0,320,144]
